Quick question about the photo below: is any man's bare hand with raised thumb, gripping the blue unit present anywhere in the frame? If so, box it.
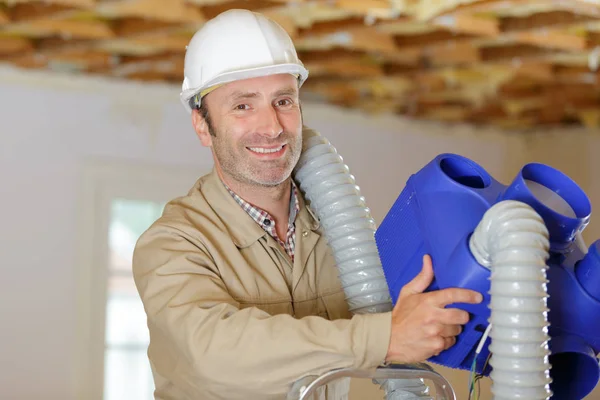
[386,255,482,363]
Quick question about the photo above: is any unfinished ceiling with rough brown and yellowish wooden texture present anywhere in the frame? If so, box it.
[0,0,600,129]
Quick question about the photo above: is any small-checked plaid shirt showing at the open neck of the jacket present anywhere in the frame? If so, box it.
[223,181,300,262]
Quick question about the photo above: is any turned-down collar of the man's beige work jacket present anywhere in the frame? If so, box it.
[199,167,320,248]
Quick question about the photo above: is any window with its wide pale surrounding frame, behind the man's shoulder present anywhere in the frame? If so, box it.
[76,162,206,400]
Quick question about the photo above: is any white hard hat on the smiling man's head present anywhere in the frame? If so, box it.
[180,9,308,112]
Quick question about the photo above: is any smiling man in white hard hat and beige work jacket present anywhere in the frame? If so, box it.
[133,10,481,400]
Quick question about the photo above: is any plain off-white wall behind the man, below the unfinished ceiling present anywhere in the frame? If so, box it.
[0,65,600,400]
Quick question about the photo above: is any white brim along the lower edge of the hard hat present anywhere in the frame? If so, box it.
[180,63,308,114]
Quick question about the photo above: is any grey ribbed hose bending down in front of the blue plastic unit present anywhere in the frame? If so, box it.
[469,200,552,400]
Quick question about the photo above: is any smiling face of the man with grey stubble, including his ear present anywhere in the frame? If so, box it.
[194,74,302,186]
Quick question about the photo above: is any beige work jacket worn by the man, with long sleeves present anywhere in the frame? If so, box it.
[133,165,391,400]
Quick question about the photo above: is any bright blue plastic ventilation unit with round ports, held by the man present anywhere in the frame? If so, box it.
[375,154,600,400]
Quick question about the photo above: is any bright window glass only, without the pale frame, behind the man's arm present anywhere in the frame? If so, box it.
[104,199,164,400]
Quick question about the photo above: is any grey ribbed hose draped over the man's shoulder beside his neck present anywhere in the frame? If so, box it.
[294,128,433,400]
